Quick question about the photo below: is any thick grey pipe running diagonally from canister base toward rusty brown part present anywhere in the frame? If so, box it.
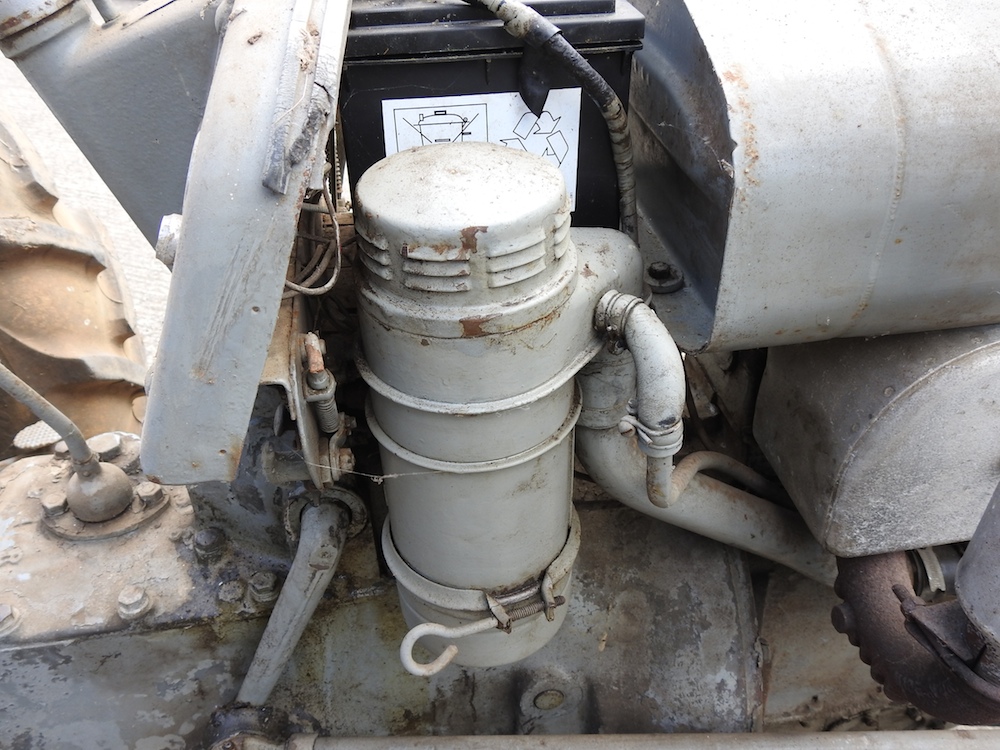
[576,425,837,586]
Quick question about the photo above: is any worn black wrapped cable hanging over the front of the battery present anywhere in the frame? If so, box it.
[465,0,639,244]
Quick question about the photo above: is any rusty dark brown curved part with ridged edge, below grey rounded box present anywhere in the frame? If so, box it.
[832,552,1000,724]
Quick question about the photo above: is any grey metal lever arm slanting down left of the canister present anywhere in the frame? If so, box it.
[236,503,349,706]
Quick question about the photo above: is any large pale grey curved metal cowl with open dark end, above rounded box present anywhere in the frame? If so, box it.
[632,0,1000,350]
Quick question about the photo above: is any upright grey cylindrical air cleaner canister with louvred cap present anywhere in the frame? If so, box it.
[355,143,593,665]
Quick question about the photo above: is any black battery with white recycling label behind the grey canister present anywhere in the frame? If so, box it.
[340,0,645,228]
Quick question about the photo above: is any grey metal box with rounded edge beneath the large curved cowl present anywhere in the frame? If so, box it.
[754,326,1000,557]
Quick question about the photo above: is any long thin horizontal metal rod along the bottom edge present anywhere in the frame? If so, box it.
[227,729,997,750]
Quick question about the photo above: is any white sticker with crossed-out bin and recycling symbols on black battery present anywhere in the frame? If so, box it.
[382,88,580,209]
